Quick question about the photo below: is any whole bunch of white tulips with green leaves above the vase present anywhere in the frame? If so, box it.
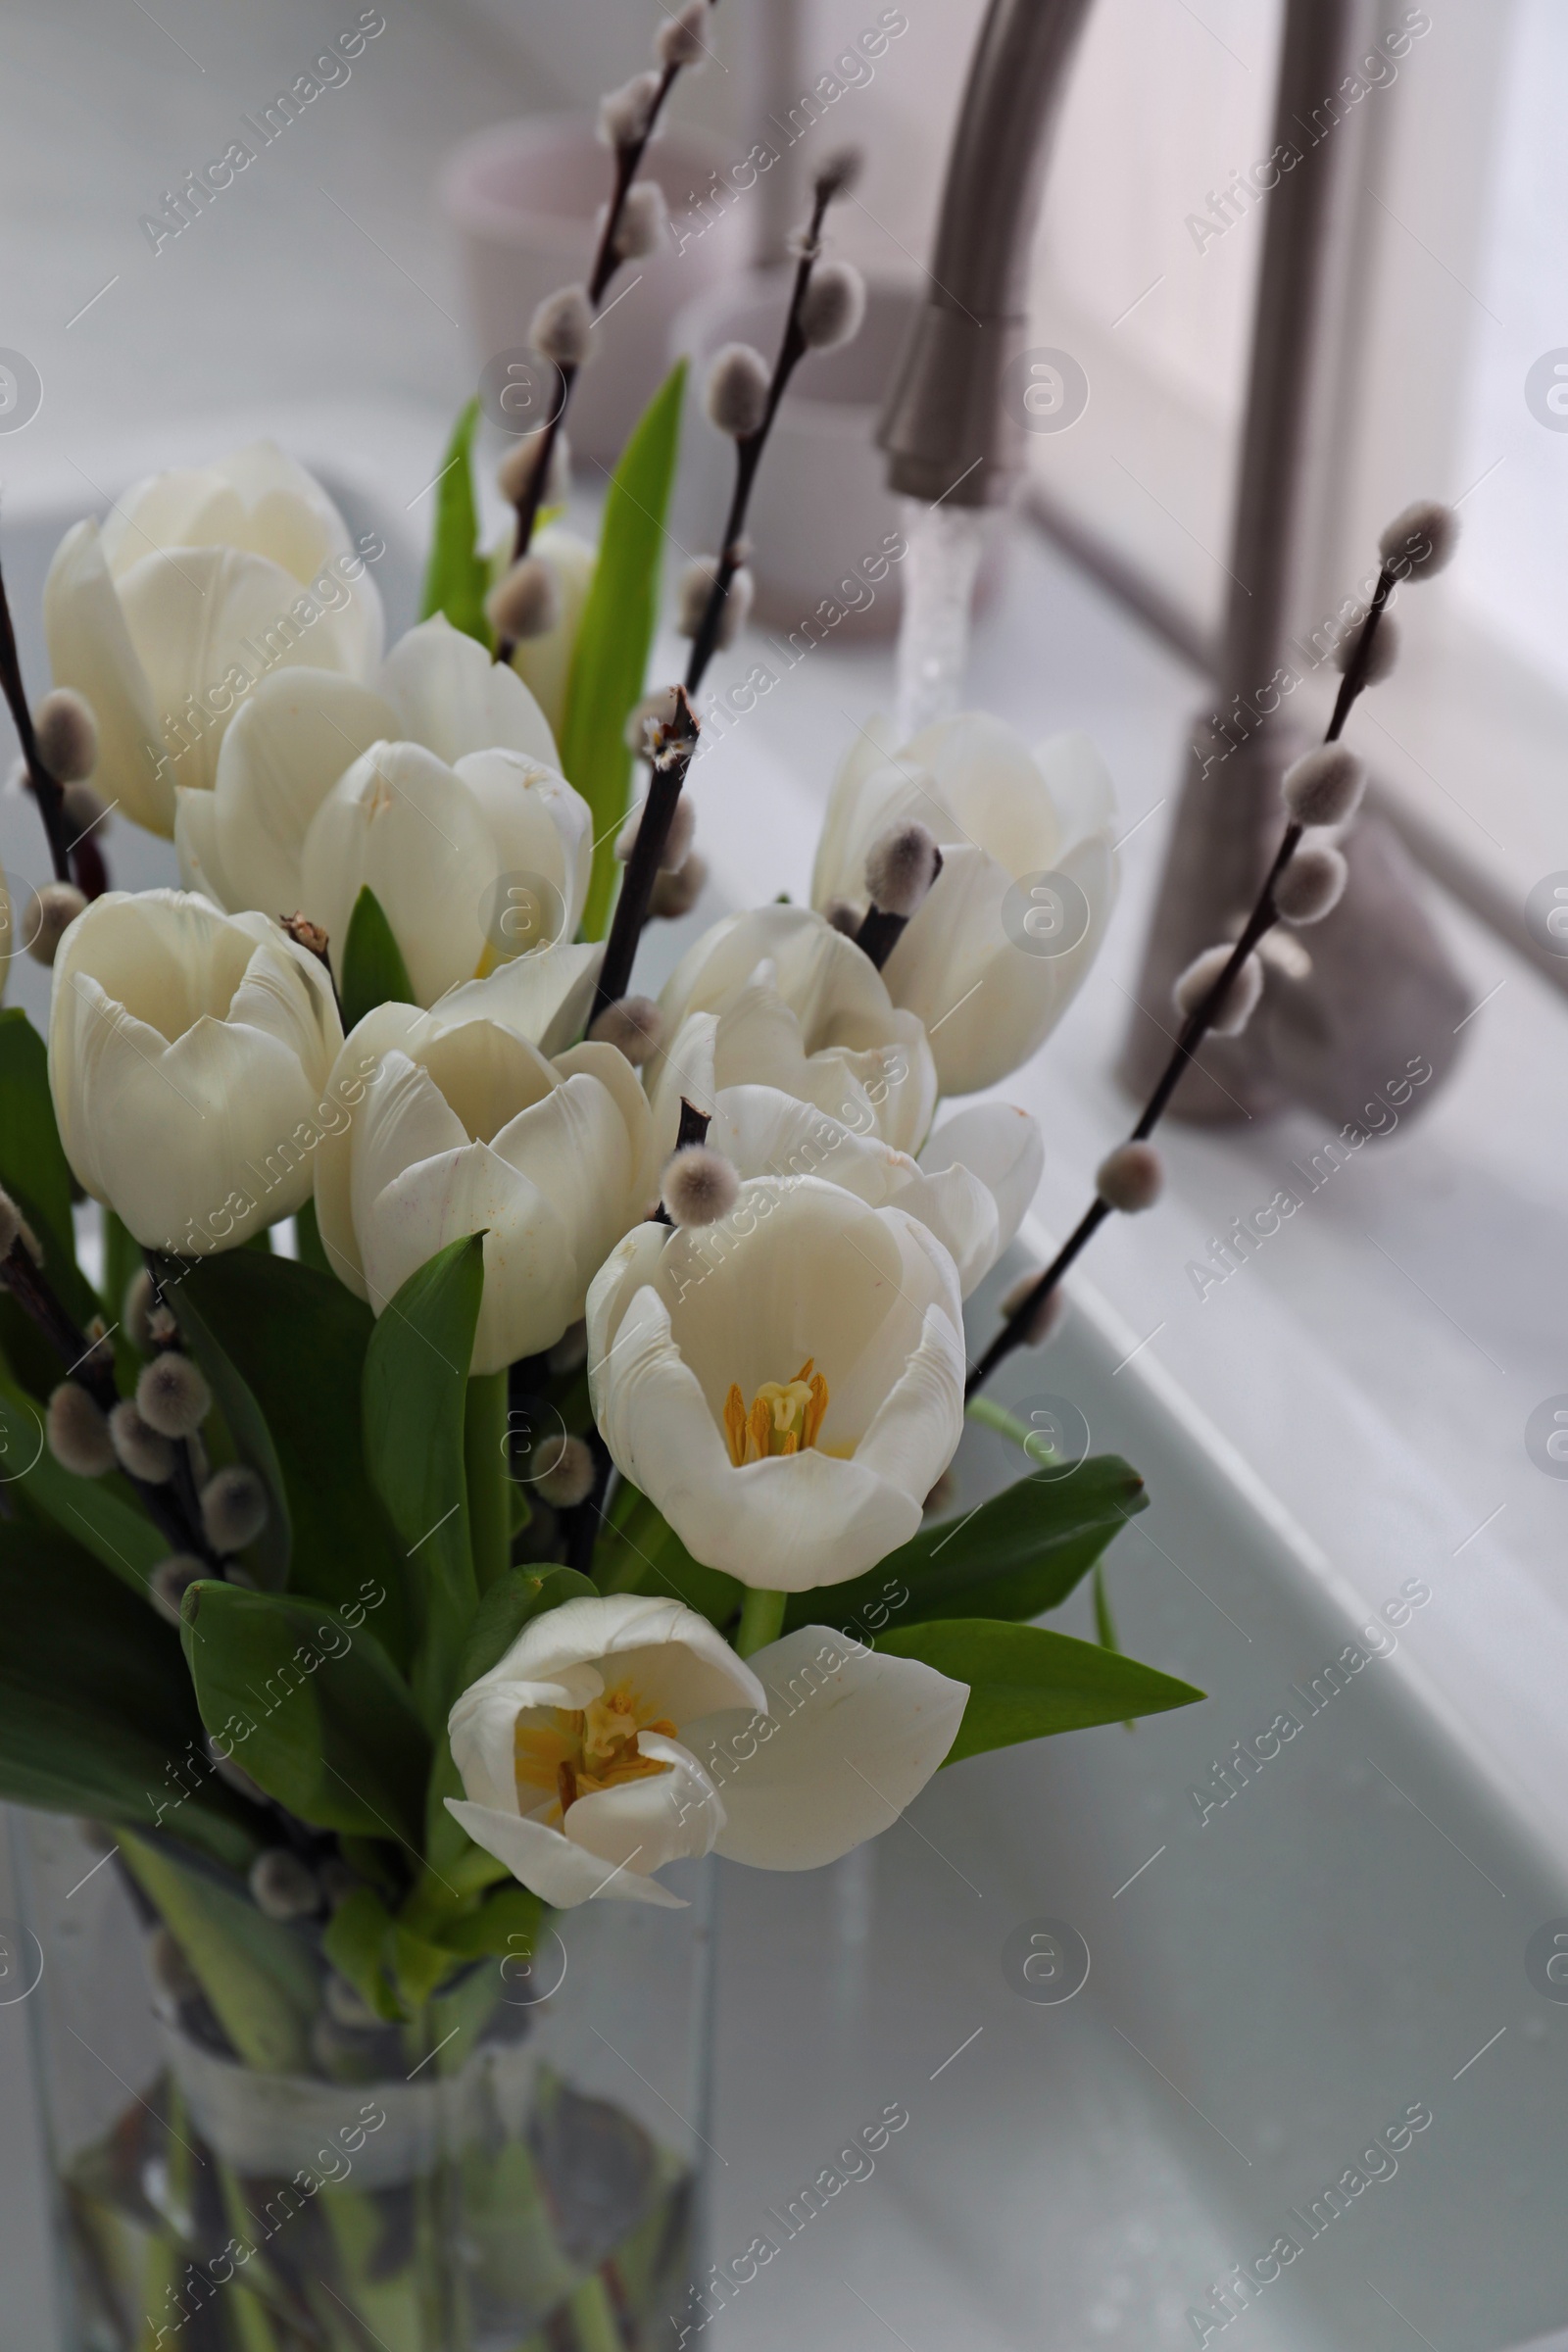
[0,371,1197,2117]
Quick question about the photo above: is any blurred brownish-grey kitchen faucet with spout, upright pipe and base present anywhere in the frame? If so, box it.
[877,0,1469,1122]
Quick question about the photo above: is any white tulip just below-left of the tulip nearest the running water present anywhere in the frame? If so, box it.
[651,906,936,1152]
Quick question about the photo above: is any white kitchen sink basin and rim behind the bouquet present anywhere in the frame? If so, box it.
[0,468,1568,2352]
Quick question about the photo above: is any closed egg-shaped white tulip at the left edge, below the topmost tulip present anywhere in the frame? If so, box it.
[49,889,343,1256]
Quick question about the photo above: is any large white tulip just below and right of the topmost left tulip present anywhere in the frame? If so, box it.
[174,613,592,1004]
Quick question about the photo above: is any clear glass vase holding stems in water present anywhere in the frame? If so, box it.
[14,1813,714,2352]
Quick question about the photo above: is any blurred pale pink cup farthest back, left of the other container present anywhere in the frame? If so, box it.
[440,116,750,466]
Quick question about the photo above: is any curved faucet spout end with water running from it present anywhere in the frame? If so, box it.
[877,0,1089,506]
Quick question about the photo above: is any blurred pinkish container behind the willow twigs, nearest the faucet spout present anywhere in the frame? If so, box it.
[670,269,999,640]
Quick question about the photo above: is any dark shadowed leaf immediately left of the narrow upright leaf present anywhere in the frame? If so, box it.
[170,1249,412,1665]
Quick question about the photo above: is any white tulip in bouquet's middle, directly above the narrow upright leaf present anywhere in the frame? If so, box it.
[315,946,659,1374]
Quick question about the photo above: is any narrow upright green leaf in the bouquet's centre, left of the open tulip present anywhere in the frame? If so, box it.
[360,1233,484,1731]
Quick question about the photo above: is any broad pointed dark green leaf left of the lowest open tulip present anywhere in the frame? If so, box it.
[181,1581,430,1851]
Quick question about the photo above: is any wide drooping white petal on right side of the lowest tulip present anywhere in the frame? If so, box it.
[684,1625,968,1870]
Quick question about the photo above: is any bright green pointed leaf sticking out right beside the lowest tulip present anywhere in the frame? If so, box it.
[877,1618,1203,1764]
